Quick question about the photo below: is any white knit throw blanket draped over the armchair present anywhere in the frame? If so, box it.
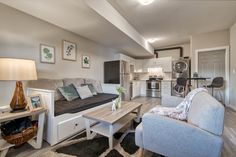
[150,88,208,120]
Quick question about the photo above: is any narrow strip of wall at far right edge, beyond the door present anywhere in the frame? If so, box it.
[230,23,236,110]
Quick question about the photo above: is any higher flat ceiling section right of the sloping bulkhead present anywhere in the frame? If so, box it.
[108,0,236,48]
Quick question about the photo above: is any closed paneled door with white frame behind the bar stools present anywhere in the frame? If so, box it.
[196,47,229,105]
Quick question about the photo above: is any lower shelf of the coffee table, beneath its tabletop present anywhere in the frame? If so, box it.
[90,115,137,137]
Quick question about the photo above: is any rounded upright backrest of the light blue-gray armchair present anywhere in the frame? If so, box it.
[188,92,225,135]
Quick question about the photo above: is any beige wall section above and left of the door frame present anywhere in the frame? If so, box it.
[190,29,230,74]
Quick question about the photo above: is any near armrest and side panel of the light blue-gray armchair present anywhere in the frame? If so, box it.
[140,113,223,157]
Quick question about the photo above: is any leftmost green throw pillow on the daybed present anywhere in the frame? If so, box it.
[58,84,79,101]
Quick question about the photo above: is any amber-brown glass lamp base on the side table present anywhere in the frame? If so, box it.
[10,81,27,112]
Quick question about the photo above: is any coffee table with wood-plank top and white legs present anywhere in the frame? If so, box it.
[83,101,142,149]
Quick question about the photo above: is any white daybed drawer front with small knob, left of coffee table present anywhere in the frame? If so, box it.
[57,116,85,141]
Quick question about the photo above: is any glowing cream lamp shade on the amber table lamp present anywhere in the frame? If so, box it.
[0,58,37,81]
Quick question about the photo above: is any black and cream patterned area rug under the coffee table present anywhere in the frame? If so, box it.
[55,130,165,157]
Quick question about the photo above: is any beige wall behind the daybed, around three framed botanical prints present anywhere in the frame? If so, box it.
[0,4,115,106]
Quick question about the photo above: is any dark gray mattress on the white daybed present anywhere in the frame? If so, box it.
[54,93,118,116]
